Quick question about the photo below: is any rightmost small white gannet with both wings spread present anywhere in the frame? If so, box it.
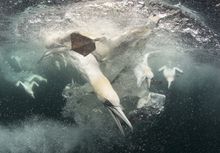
[159,63,183,89]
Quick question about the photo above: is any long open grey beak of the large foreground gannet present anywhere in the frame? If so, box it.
[104,101,133,135]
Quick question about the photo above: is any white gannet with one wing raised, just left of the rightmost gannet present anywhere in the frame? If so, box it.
[134,51,158,88]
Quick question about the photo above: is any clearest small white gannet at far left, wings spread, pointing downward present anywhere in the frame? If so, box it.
[16,81,39,98]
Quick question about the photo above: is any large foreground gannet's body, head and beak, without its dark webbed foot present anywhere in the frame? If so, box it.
[69,51,133,135]
